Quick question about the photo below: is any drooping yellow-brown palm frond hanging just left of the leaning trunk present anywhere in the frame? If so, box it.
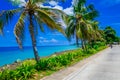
[14,12,26,48]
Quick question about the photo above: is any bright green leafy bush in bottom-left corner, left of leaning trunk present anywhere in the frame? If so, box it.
[0,61,36,80]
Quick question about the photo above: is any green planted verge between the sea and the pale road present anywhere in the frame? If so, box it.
[0,46,106,80]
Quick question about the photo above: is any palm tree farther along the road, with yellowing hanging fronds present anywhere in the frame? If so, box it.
[63,0,98,48]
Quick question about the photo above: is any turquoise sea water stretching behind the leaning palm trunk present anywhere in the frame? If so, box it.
[0,45,77,66]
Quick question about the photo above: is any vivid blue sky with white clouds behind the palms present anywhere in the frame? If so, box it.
[0,0,120,47]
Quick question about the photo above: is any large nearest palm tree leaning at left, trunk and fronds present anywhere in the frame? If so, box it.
[0,0,64,62]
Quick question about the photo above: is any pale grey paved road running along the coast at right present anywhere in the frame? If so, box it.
[63,46,120,80]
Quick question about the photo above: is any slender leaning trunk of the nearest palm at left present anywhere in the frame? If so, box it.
[29,14,40,63]
